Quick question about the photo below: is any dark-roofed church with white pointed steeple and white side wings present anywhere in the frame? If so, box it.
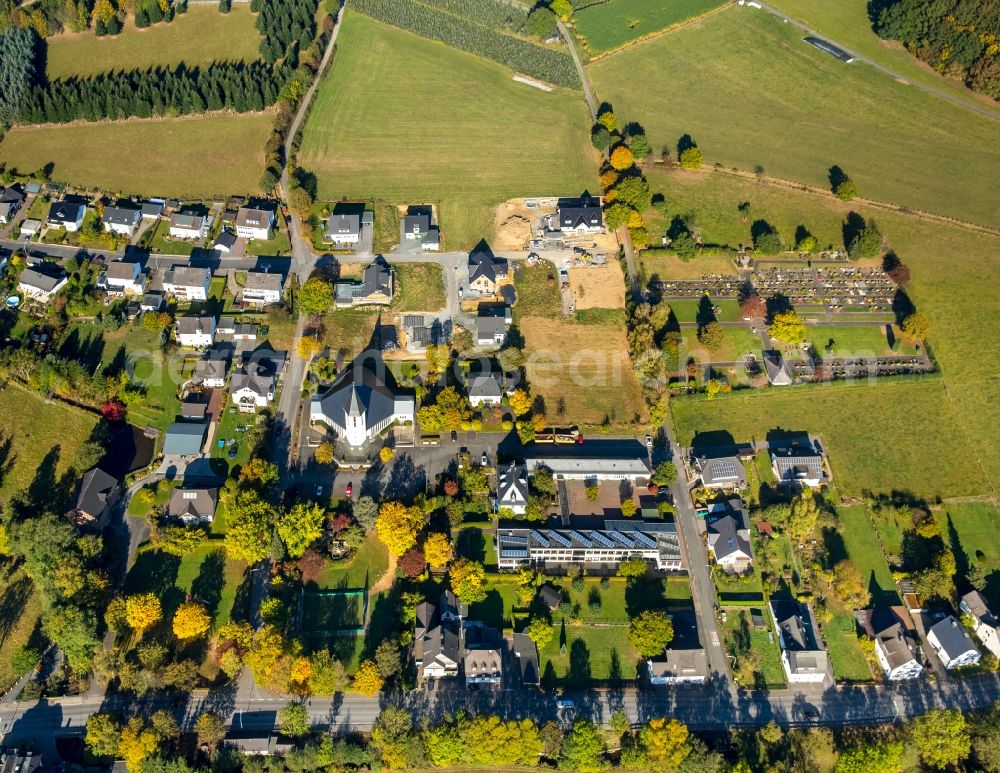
[309,322,416,448]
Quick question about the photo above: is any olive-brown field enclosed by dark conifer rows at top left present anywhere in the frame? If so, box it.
[45,5,260,79]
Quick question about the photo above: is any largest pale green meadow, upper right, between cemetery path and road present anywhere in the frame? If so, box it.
[588,6,1000,226]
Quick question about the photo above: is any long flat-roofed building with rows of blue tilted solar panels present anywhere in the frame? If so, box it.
[494,520,682,571]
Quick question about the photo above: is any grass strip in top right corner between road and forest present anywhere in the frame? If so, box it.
[771,0,996,109]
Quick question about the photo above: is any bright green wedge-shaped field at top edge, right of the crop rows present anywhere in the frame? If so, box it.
[573,0,726,54]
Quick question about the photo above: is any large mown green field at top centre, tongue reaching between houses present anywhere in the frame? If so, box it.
[296,12,597,249]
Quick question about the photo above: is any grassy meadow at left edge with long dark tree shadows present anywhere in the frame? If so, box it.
[0,382,99,504]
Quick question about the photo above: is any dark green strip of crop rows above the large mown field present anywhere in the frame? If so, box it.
[350,0,581,89]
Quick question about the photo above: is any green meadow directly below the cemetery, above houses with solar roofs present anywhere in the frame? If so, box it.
[670,378,986,496]
